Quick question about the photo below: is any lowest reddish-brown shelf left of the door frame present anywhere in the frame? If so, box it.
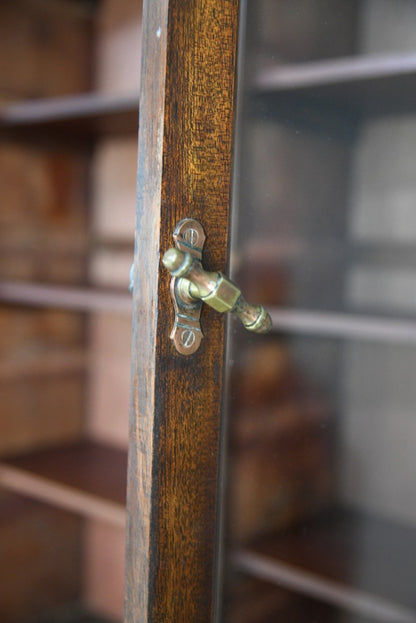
[0,441,127,527]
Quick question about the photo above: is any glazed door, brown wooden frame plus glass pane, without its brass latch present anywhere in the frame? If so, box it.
[126,0,416,623]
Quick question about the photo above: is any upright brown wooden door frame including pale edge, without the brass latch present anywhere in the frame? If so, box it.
[125,0,239,623]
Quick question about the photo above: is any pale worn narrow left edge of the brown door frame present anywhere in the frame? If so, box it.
[124,0,169,623]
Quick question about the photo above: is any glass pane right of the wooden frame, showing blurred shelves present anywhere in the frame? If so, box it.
[224,0,416,623]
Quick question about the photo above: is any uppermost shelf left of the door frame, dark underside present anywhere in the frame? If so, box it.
[0,93,139,141]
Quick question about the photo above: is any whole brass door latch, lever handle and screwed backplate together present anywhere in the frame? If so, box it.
[162,219,272,355]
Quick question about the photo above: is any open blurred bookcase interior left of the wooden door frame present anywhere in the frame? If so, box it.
[0,0,141,623]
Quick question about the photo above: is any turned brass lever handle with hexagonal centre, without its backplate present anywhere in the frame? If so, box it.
[162,248,272,333]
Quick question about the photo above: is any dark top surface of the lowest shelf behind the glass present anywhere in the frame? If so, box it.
[236,507,416,618]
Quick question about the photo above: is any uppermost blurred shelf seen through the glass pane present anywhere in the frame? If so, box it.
[251,54,416,116]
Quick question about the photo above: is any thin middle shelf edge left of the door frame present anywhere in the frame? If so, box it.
[0,281,132,314]
